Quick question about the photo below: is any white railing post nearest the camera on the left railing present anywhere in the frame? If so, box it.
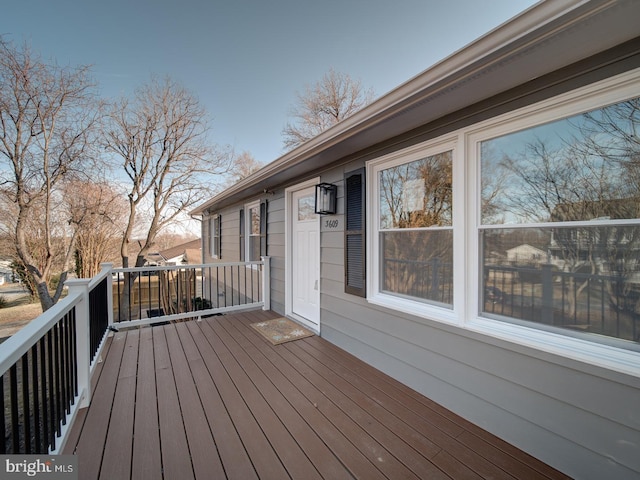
[65,278,91,408]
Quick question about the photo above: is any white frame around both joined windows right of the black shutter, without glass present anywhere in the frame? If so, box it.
[366,69,640,377]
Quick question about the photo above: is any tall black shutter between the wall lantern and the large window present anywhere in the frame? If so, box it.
[344,168,367,297]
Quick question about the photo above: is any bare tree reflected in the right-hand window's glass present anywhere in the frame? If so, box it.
[492,100,640,316]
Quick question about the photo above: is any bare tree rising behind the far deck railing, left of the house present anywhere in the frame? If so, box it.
[104,78,229,267]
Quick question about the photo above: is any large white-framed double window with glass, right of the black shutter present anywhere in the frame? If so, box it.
[356,70,640,372]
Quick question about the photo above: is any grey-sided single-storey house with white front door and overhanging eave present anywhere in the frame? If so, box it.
[193,0,640,479]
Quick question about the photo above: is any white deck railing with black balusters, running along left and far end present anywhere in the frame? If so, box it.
[0,258,269,454]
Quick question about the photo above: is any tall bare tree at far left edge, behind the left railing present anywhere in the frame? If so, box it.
[0,39,99,311]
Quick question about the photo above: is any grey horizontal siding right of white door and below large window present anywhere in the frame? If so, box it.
[321,158,640,479]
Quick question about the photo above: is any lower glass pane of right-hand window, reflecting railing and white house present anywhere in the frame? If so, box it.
[482,226,640,341]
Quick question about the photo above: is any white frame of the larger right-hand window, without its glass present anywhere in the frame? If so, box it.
[463,69,640,376]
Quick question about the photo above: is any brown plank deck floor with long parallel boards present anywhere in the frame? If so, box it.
[64,311,567,480]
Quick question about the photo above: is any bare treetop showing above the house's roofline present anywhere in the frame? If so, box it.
[282,69,374,150]
